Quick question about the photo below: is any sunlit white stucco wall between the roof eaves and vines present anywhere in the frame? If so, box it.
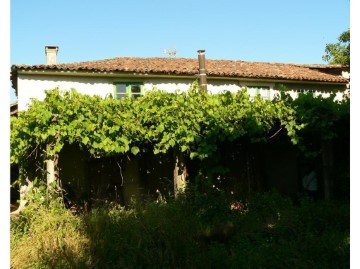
[17,74,348,111]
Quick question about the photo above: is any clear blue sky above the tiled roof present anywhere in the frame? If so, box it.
[10,0,350,100]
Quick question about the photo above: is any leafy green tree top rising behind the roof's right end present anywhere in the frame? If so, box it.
[322,29,350,65]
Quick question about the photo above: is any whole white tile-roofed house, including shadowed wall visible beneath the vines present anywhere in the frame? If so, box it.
[11,46,349,203]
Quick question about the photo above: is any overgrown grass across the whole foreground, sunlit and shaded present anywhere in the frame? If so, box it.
[11,188,350,269]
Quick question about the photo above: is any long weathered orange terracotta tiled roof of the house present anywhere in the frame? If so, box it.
[12,57,348,83]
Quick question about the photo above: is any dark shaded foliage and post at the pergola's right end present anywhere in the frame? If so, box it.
[283,93,350,200]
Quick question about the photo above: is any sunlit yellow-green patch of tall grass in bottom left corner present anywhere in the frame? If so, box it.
[10,196,91,268]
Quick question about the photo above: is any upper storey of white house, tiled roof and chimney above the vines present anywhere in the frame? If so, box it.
[11,46,349,111]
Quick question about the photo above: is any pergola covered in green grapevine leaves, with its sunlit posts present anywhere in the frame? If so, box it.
[11,81,349,205]
